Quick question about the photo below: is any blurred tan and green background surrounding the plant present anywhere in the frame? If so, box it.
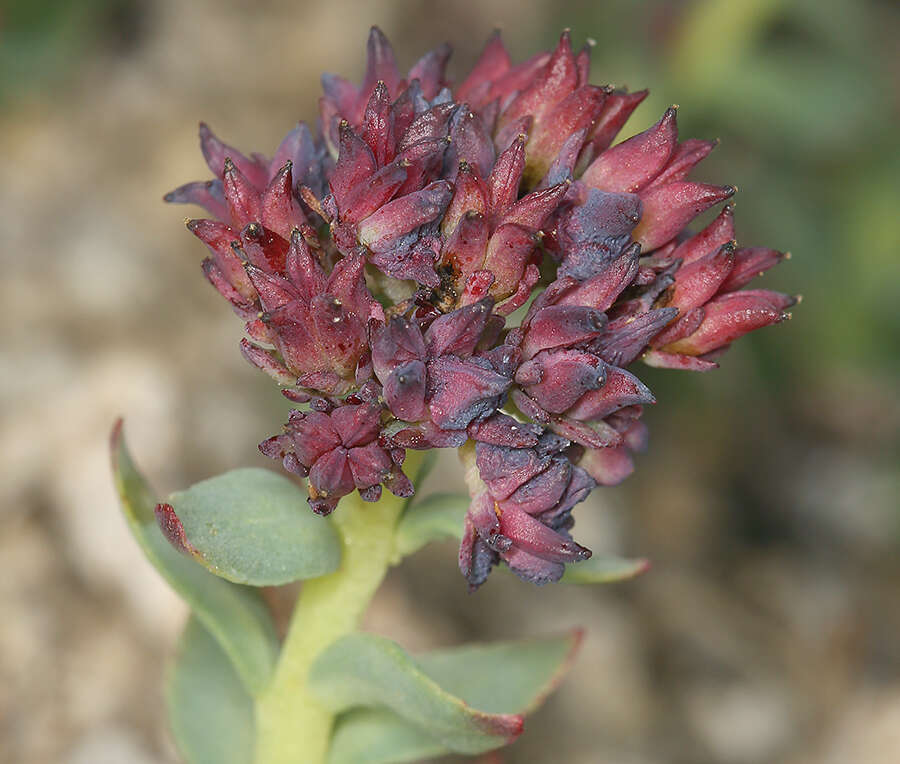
[0,0,900,764]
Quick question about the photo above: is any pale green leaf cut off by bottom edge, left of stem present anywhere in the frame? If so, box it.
[166,617,255,764]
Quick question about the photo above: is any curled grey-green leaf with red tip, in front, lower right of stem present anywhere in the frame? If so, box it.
[308,633,523,754]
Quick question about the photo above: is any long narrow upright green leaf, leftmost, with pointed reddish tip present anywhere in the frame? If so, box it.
[111,420,278,693]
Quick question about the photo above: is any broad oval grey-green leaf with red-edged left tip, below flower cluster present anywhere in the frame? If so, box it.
[164,469,341,586]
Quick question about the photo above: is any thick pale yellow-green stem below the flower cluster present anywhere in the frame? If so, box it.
[255,452,419,764]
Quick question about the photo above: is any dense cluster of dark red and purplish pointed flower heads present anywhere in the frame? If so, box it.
[166,29,793,587]
